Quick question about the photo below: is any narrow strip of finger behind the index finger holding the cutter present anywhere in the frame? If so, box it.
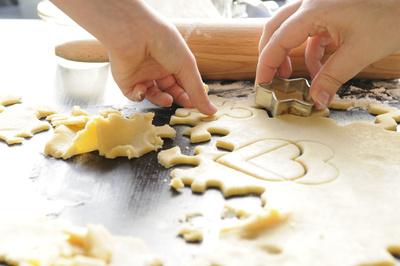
[258,0,302,54]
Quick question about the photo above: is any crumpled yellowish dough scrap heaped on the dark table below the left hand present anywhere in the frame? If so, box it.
[44,112,175,159]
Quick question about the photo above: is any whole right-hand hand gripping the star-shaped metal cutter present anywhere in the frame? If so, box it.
[256,0,400,108]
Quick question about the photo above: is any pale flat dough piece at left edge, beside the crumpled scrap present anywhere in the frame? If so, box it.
[0,106,50,145]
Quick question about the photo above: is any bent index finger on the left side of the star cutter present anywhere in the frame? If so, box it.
[256,12,314,83]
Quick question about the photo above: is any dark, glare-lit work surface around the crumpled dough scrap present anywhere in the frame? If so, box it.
[0,21,398,265]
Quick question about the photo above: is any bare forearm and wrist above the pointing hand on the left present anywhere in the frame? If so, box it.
[52,0,162,58]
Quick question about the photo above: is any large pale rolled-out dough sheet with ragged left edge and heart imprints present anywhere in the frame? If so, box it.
[166,95,400,266]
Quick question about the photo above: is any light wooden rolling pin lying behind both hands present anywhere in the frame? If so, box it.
[55,19,400,80]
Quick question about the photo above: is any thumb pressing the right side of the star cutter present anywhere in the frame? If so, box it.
[310,45,369,109]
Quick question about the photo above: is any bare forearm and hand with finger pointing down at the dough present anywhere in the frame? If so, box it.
[52,0,217,115]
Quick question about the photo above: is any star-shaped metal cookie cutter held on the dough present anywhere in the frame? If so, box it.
[256,78,314,116]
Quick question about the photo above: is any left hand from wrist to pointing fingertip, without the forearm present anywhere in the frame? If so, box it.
[110,6,216,114]
